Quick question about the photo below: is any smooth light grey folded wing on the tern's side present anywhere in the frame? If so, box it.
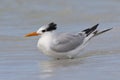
[51,34,85,52]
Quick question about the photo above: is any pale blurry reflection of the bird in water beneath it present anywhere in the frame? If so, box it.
[39,58,83,78]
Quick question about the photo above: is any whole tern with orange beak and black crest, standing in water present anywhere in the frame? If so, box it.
[25,22,113,60]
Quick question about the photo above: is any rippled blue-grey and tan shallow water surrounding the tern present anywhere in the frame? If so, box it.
[0,0,120,80]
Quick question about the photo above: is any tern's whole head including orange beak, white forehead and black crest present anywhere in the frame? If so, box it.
[25,22,57,37]
